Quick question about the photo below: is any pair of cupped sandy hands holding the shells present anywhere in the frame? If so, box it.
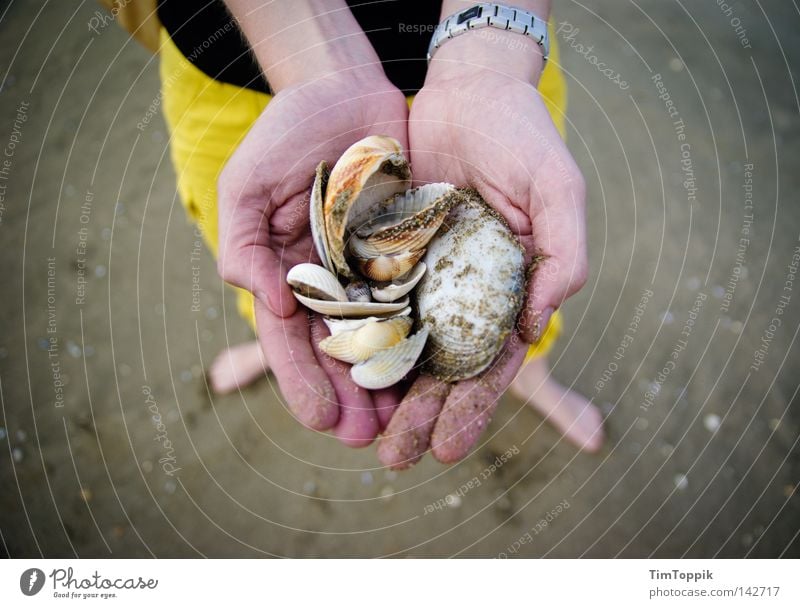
[218,61,586,468]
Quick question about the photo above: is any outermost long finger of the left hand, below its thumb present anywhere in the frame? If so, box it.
[255,301,339,431]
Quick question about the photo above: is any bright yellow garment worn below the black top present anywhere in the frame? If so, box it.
[159,29,567,358]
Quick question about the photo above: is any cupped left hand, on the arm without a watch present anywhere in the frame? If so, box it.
[218,74,408,446]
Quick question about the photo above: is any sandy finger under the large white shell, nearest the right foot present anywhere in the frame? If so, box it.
[431,335,528,463]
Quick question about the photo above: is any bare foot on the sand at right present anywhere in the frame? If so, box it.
[509,357,605,452]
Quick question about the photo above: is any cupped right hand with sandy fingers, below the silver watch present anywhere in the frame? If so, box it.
[379,34,587,468]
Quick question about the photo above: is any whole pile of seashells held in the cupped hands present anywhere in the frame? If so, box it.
[287,136,525,389]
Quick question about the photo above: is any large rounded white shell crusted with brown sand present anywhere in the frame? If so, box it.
[416,191,526,382]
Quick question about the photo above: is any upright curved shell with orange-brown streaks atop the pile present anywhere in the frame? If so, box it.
[324,135,411,277]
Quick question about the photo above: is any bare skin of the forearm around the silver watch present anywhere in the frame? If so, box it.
[428,0,551,83]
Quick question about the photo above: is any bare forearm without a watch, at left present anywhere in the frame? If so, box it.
[225,0,383,91]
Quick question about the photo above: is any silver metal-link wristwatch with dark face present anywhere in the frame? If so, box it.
[428,2,550,61]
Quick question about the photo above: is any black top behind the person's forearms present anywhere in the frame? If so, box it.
[158,0,442,95]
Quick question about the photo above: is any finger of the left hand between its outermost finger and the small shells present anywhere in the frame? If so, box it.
[312,316,378,448]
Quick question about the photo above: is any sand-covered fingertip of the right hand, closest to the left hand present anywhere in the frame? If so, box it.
[378,375,450,469]
